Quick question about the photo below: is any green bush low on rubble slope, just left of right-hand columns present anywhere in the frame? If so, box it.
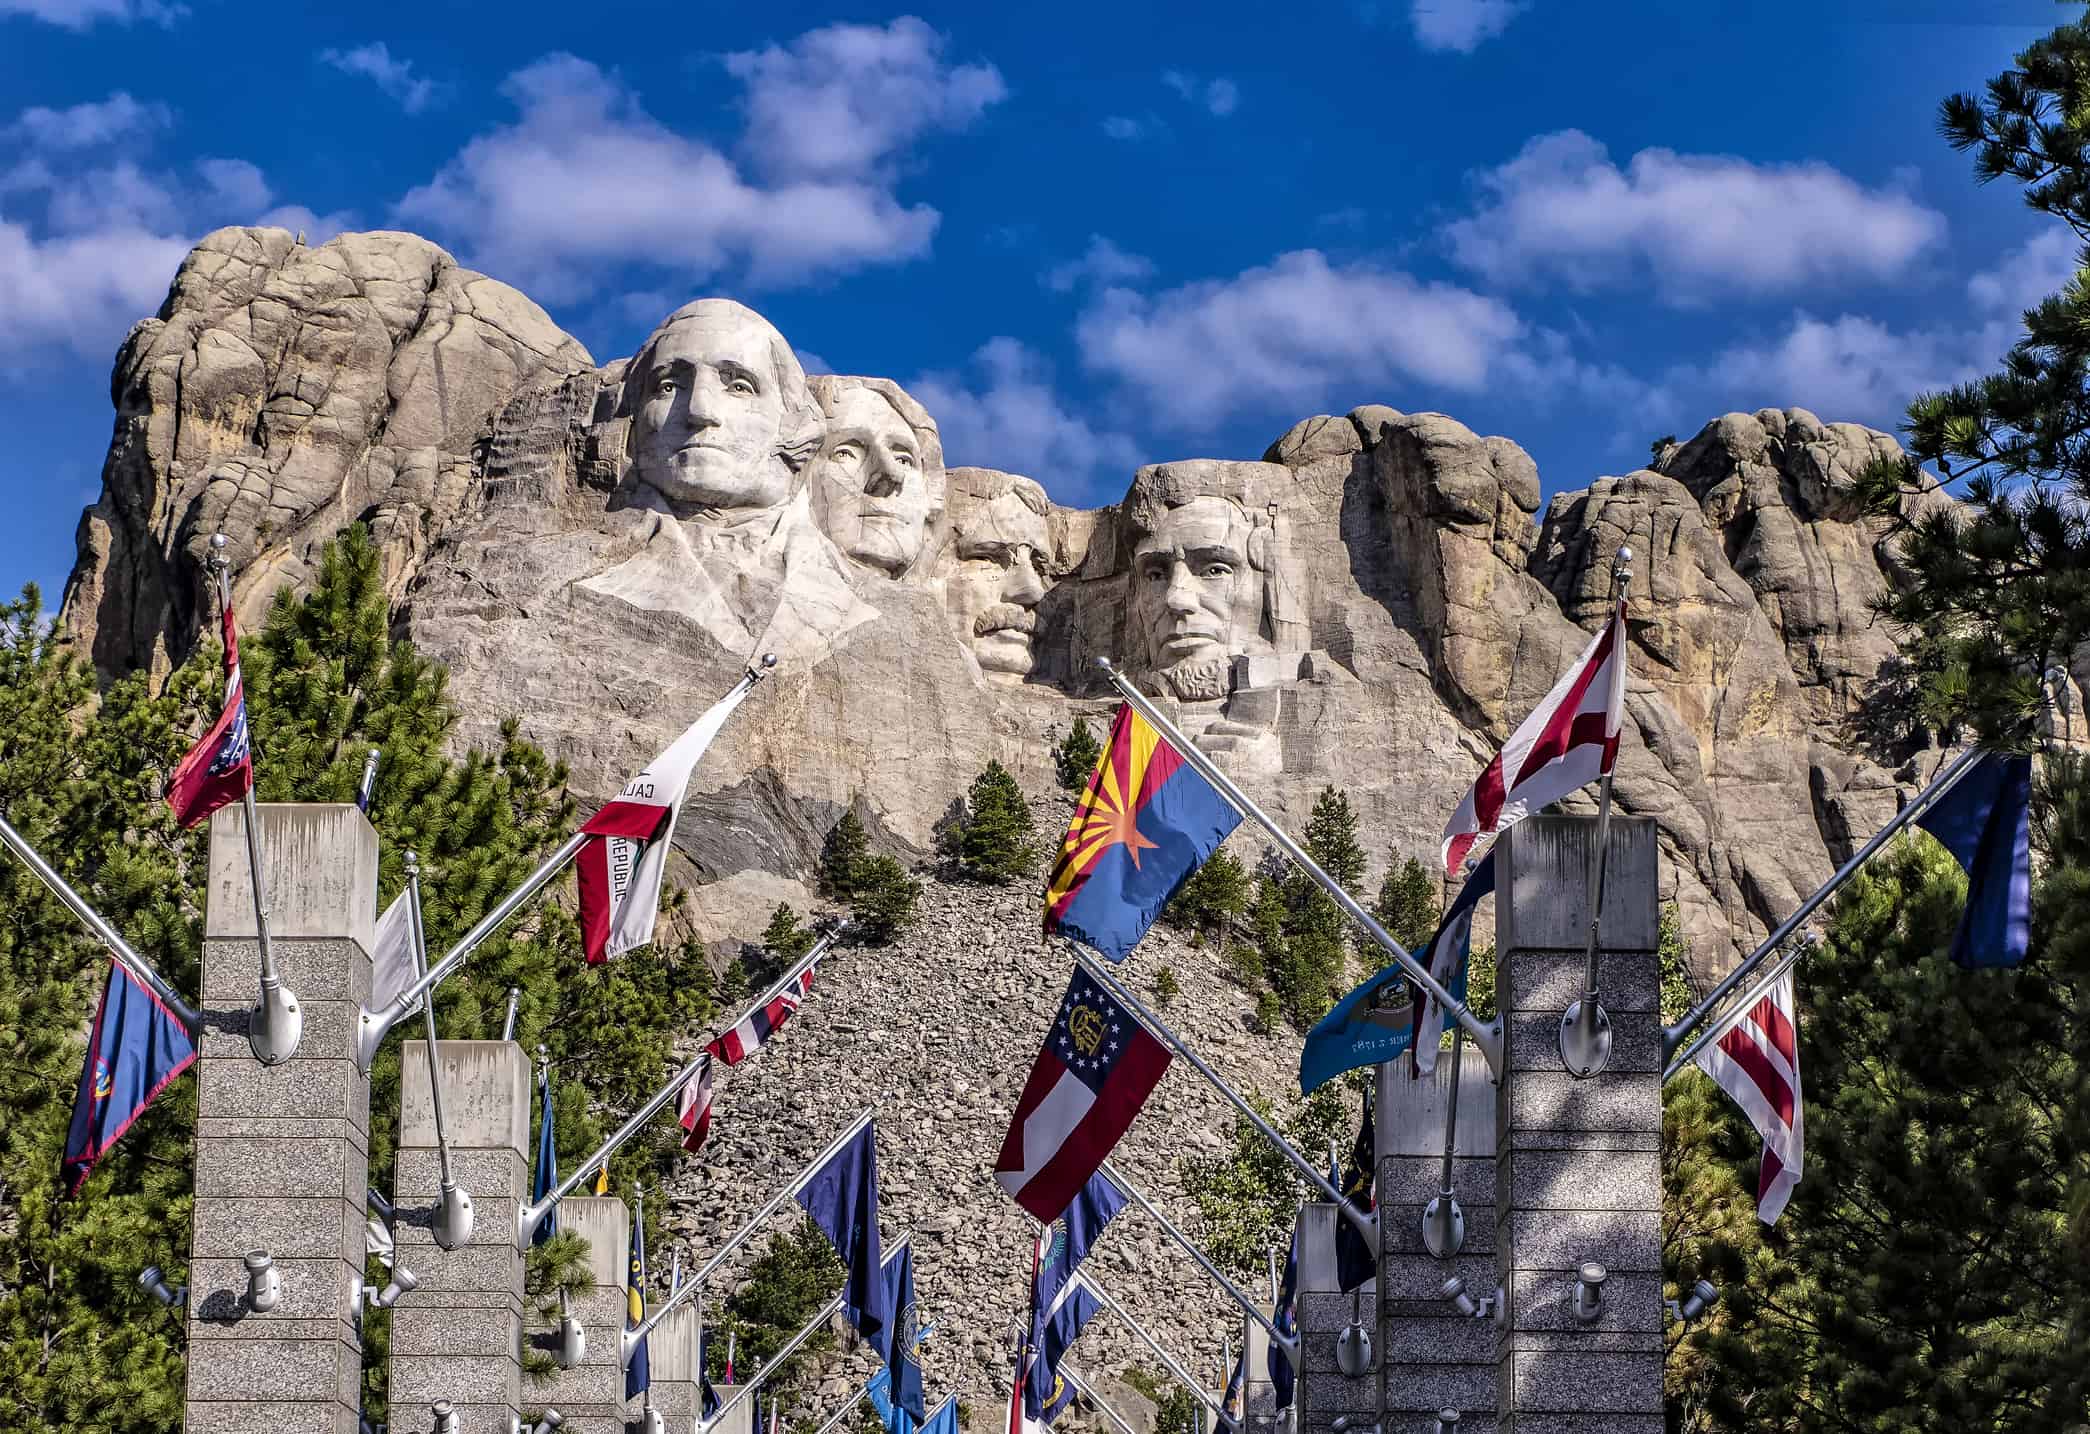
[1181,1085,1356,1279]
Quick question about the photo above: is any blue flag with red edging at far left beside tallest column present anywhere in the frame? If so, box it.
[61,959,196,1194]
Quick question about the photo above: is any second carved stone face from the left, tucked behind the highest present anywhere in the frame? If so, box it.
[813,389,930,575]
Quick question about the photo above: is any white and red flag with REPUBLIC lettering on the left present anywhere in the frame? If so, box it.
[575,673,754,966]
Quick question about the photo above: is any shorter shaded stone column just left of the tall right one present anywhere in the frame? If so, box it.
[1377,1041,1496,1434]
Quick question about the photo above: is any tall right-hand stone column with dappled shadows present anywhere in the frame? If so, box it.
[1504,815,1662,1434]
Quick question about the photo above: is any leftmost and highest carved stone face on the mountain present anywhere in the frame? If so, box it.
[625,301,794,508]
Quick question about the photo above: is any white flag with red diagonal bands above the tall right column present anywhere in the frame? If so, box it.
[1442,598,1626,876]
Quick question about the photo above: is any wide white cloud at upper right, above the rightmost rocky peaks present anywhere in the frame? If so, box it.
[1444,130,1946,305]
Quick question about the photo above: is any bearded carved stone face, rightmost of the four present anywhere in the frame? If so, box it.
[1131,498,1269,696]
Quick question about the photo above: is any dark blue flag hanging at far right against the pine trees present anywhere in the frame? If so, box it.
[1917,753,2031,968]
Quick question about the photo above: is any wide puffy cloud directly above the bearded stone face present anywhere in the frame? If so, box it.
[1076,249,1565,429]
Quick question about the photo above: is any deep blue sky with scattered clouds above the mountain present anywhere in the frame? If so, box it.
[0,0,2073,602]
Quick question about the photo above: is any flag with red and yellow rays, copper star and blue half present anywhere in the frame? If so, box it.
[1045,702,1241,962]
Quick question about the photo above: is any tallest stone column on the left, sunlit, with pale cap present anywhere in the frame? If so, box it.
[184,805,378,1434]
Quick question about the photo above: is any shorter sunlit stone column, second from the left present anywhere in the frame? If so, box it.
[387,1045,531,1434]
